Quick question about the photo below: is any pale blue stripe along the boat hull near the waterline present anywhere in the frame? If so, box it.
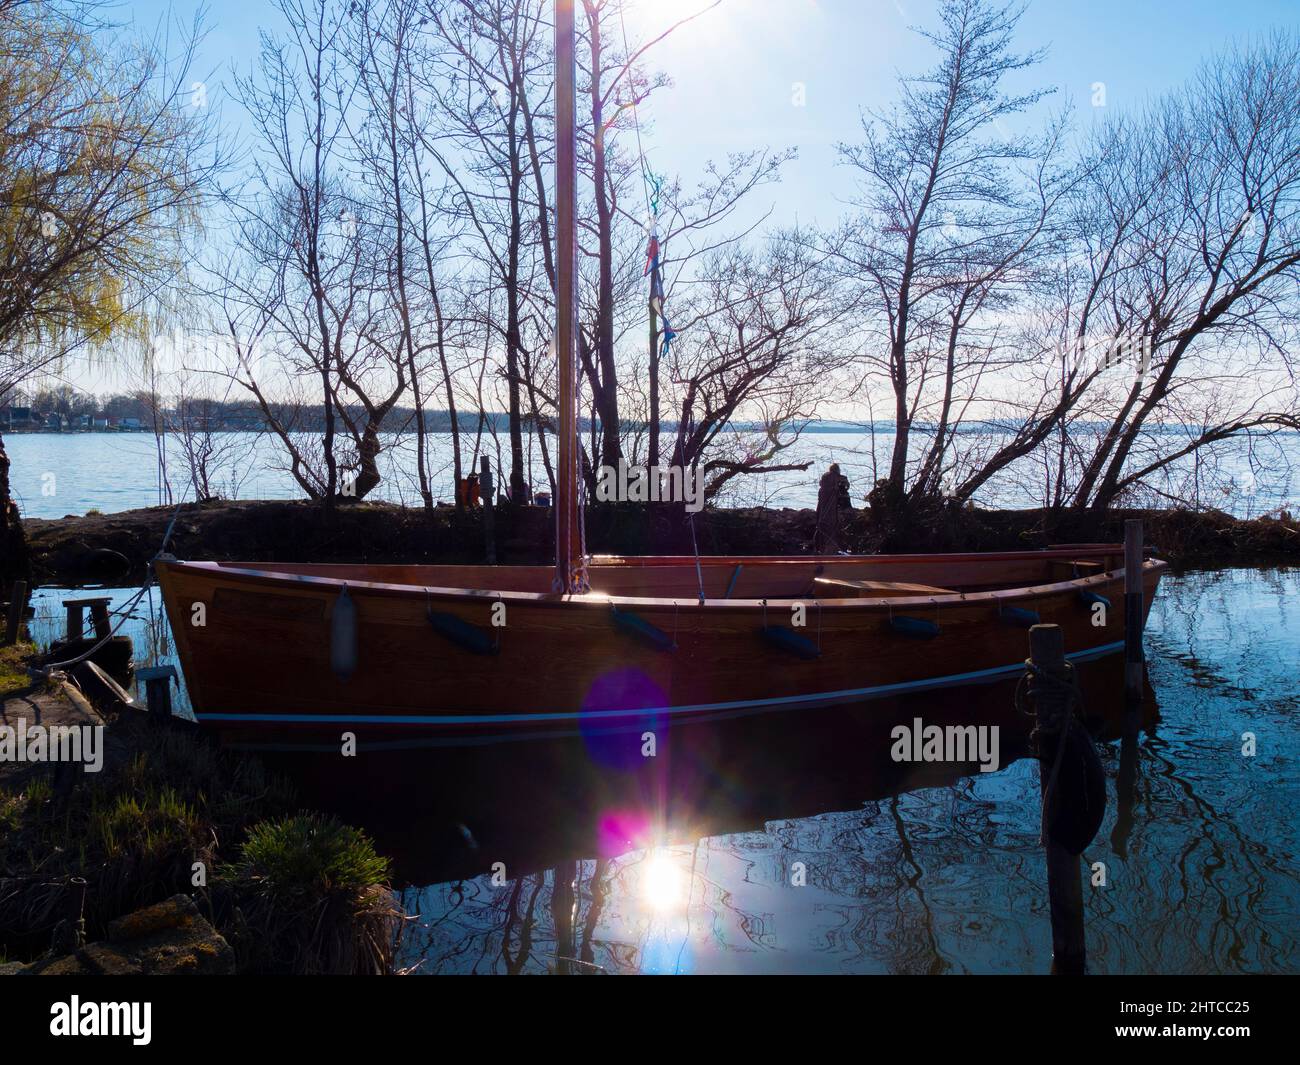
[195,640,1125,726]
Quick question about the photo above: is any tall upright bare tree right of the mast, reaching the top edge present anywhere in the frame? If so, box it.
[828,0,1054,499]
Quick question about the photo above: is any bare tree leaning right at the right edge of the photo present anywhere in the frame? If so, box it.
[1074,33,1300,507]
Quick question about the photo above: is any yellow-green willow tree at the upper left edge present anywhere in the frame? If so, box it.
[0,0,216,576]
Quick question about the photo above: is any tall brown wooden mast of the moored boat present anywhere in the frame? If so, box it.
[554,0,586,594]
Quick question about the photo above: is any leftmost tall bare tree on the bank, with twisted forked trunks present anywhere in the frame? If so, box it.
[221,0,410,507]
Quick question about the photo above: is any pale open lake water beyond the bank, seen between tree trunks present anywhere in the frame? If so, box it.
[5,432,1300,518]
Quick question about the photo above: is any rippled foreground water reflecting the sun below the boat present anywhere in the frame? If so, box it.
[22,570,1300,973]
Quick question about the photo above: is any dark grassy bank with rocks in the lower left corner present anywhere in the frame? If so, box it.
[0,645,402,974]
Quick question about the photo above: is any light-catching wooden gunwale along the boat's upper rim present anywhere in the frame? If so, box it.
[160,551,1169,612]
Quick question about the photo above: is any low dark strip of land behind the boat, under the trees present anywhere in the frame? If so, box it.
[23,501,1300,584]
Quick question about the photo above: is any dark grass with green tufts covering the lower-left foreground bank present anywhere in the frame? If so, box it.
[0,724,400,973]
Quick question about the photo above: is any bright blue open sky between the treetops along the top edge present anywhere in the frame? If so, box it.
[77,0,1300,400]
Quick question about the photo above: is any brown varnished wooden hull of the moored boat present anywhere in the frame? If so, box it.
[157,545,1165,746]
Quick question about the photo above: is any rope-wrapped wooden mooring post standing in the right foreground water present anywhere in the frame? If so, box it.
[1030,625,1087,974]
